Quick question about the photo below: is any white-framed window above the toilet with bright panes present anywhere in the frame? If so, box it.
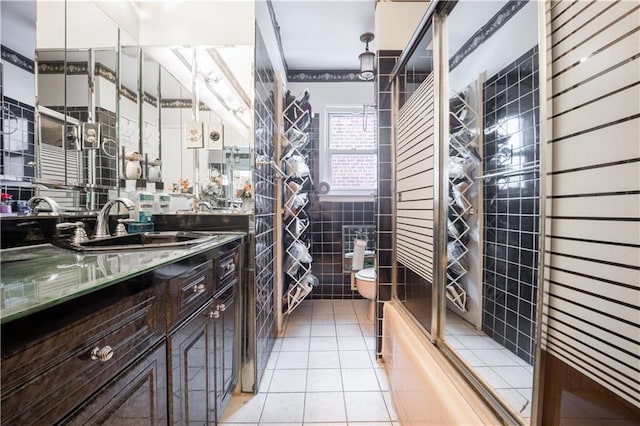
[320,106,378,196]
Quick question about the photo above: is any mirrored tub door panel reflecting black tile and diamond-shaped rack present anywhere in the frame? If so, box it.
[444,1,539,424]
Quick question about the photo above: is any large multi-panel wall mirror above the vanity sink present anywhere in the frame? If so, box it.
[2,1,254,210]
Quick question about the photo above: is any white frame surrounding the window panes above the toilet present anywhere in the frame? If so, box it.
[318,105,378,201]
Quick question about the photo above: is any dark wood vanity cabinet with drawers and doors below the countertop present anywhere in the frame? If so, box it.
[0,234,243,425]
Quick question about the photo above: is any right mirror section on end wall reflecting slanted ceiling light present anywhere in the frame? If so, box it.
[153,47,252,209]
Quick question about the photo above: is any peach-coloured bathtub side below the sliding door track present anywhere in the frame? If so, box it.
[382,301,502,426]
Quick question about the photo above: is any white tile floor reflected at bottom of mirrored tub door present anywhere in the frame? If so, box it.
[445,315,533,423]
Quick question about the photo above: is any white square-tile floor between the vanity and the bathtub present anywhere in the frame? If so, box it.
[221,300,400,426]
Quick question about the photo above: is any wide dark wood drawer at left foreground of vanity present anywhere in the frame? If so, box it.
[0,274,164,425]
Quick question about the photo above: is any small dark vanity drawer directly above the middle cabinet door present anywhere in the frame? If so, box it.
[163,260,215,329]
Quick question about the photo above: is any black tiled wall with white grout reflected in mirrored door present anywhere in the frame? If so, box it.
[483,46,540,364]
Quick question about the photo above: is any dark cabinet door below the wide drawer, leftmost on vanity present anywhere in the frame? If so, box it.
[62,342,167,426]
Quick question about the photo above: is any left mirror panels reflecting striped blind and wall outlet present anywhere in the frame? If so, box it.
[22,2,118,210]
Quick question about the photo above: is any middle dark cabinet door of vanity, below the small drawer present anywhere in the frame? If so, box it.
[167,301,215,425]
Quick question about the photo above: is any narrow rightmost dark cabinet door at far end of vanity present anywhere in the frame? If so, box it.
[214,287,238,420]
